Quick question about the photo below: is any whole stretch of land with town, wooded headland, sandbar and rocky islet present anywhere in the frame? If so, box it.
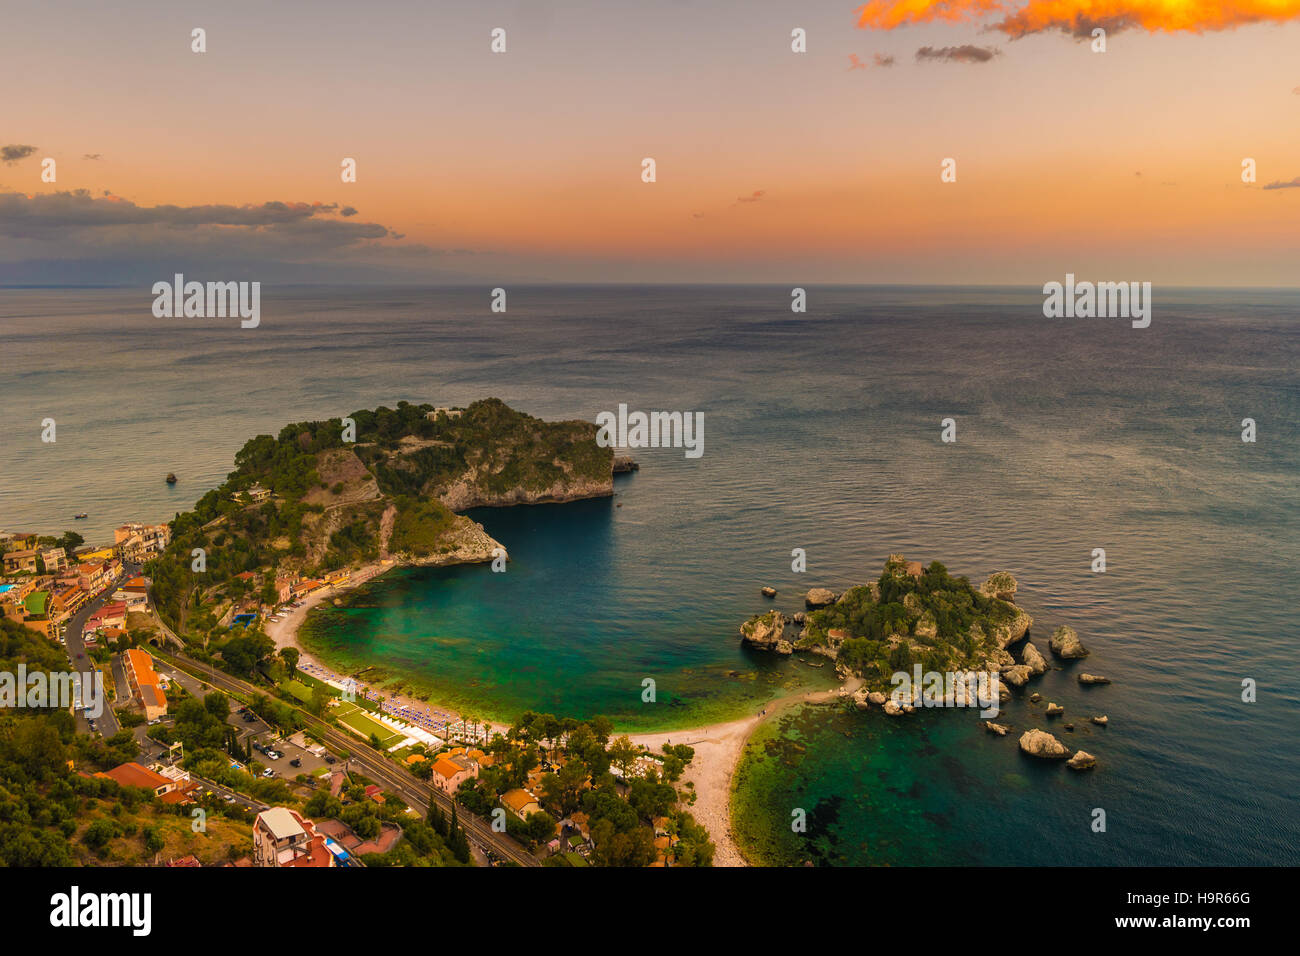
[0,399,1109,868]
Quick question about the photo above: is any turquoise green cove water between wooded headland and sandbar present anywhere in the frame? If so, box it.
[299,494,832,730]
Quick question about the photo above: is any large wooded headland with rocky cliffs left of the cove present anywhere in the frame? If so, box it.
[150,398,616,644]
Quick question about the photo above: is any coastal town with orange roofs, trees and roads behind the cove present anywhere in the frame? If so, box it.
[0,502,714,868]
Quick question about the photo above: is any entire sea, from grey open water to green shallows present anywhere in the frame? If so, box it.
[0,286,1300,866]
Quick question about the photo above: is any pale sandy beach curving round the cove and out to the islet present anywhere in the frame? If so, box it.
[267,561,861,866]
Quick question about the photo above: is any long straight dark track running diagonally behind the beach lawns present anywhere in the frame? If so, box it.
[163,653,541,866]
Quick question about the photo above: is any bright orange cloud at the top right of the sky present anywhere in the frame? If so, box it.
[858,0,1300,38]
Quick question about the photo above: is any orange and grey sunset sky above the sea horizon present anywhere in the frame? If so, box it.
[0,0,1300,286]
